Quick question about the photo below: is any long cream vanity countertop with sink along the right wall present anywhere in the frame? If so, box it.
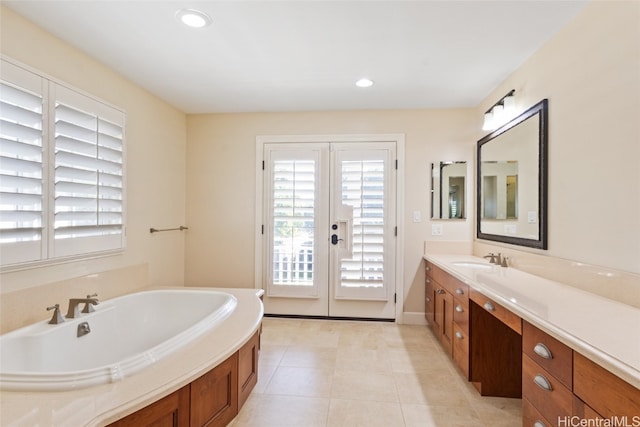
[424,254,640,388]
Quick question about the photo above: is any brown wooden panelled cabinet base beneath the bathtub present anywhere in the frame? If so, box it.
[110,330,260,427]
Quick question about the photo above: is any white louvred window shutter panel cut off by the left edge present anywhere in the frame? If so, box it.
[0,61,46,265]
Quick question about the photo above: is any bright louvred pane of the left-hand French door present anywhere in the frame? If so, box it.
[272,160,316,286]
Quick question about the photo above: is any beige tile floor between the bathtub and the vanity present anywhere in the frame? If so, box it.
[230,318,522,427]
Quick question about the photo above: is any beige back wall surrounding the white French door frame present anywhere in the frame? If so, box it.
[185,109,474,312]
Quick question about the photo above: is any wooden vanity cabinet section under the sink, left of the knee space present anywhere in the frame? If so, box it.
[425,262,469,378]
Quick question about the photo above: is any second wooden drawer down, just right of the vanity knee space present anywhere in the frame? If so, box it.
[522,354,573,420]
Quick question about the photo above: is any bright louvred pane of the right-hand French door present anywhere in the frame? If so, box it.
[340,160,385,288]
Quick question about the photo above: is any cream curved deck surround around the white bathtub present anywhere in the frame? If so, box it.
[0,288,263,427]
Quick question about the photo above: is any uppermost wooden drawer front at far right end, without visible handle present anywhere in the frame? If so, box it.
[573,352,640,420]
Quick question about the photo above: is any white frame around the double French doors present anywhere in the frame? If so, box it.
[254,133,405,323]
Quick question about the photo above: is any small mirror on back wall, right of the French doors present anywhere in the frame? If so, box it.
[431,162,467,219]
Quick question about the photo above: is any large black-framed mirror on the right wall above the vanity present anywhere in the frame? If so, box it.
[476,99,548,249]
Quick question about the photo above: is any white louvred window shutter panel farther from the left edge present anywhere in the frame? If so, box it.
[53,86,124,257]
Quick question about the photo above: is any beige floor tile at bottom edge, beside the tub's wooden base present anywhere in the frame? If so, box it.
[233,394,329,427]
